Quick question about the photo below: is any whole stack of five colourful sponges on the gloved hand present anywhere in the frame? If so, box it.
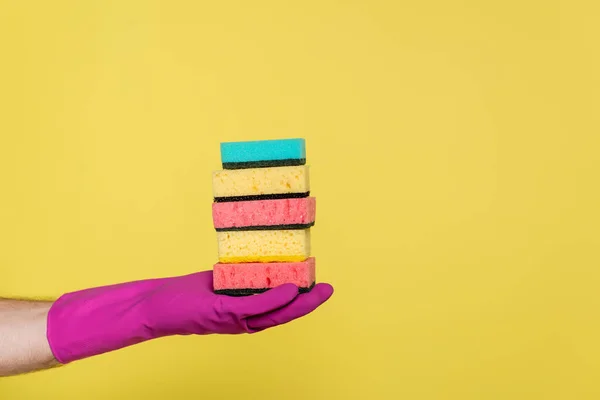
[212,139,316,296]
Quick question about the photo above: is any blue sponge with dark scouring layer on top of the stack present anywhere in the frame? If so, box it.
[221,139,306,169]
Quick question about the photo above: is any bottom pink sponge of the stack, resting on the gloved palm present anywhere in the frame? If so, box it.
[213,257,315,296]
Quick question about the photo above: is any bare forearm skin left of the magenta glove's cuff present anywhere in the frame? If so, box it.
[0,298,59,376]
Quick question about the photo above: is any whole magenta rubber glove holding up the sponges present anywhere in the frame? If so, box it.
[47,271,333,364]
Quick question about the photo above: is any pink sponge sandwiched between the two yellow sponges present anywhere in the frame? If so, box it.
[212,197,316,231]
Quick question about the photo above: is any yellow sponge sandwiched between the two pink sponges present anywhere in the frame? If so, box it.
[217,228,310,263]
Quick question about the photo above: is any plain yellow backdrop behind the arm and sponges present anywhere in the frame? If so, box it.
[0,0,600,400]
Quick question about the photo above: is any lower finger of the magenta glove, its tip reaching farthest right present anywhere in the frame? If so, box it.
[247,283,333,332]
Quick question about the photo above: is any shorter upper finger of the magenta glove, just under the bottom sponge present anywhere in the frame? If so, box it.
[227,283,298,318]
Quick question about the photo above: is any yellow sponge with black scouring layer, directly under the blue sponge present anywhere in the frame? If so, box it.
[213,165,310,201]
